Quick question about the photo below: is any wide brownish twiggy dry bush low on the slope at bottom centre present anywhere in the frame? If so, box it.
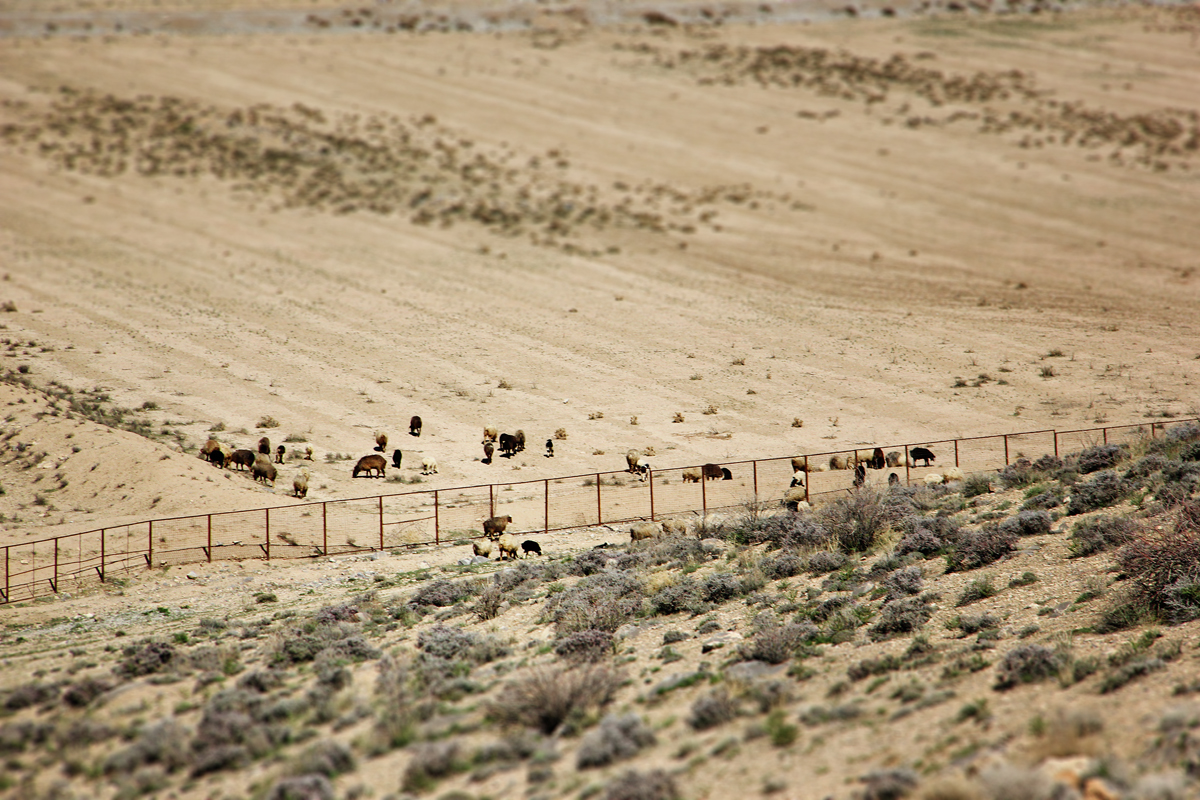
[491,664,624,735]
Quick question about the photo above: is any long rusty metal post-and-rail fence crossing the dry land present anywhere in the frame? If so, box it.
[0,419,1200,604]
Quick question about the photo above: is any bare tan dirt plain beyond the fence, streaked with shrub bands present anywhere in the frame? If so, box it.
[0,0,1200,796]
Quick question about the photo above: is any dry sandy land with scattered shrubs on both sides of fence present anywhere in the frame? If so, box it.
[0,0,1200,799]
